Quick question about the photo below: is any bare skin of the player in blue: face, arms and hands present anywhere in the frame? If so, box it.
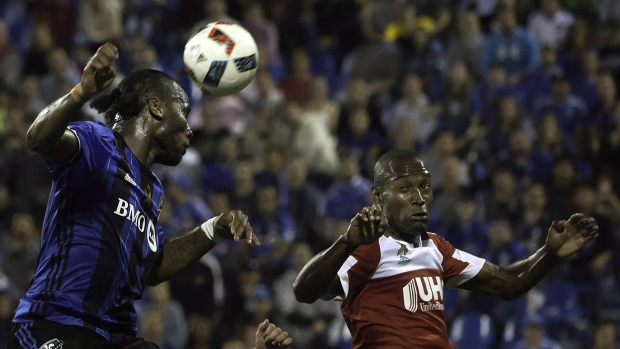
[27,43,260,285]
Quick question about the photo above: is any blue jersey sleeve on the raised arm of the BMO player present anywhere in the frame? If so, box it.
[48,121,115,174]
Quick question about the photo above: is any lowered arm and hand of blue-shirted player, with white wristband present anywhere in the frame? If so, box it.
[146,210,260,286]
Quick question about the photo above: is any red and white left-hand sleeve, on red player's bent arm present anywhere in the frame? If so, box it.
[334,242,381,301]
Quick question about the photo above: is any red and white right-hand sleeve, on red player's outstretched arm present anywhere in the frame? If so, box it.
[429,234,485,288]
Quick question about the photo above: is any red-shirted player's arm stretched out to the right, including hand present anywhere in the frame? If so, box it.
[461,213,598,300]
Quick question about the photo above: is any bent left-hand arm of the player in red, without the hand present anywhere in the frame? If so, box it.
[293,236,355,303]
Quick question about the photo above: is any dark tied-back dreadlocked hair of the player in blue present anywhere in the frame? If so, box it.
[90,69,174,127]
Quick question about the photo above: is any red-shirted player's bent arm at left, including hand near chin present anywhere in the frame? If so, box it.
[293,204,387,303]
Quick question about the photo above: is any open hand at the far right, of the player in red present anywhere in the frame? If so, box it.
[547,213,598,258]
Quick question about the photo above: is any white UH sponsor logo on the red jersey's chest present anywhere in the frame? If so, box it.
[403,276,443,313]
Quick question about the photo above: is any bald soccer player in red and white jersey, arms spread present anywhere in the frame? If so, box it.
[294,150,598,349]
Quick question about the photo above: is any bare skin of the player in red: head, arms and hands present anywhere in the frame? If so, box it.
[293,151,598,303]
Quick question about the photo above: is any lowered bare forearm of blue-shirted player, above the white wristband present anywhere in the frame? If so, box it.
[147,227,215,285]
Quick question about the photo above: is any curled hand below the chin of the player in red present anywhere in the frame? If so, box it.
[345,204,387,247]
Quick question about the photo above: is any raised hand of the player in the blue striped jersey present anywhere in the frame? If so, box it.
[80,42,118,100]
